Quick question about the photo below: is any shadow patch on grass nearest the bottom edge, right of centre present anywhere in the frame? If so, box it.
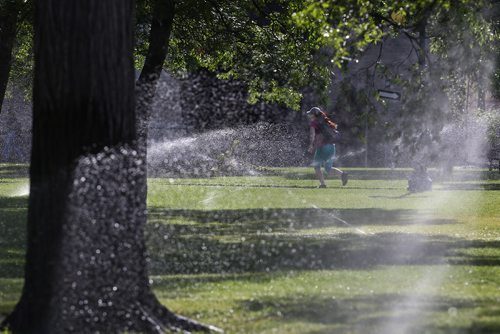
[240,294,500,334]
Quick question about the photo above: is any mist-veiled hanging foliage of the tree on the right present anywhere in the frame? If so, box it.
[309,0,500,162]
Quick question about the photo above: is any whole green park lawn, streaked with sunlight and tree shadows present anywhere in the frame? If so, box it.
[0,165,500,334]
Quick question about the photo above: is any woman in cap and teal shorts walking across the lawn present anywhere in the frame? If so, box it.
[307,107,348,188]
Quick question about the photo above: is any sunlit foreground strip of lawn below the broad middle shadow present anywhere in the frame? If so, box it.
[153,266,500,333]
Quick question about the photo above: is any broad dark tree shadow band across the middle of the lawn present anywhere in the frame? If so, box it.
[147,209,500,275]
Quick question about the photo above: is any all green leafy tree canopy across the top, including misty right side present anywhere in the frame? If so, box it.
[0,0,500,160]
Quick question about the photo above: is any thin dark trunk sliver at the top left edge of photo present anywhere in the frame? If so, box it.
[0,0,19,112]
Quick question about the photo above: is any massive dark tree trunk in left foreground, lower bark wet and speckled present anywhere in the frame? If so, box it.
[1,0,217,333]
